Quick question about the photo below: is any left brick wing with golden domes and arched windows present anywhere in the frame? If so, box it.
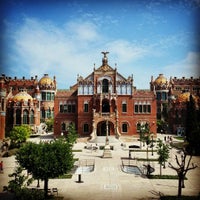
[0,74,56,139]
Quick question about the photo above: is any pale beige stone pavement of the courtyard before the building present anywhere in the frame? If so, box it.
[0,135,200,200]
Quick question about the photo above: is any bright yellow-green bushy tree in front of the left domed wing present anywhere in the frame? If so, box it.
[10,125,31,147]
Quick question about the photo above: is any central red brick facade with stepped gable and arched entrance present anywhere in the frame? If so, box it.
[54,52,156,139]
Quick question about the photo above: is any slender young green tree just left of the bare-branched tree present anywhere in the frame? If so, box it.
[157,139,169,176]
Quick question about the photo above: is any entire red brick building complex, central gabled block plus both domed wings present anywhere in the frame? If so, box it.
[0,52,200,139]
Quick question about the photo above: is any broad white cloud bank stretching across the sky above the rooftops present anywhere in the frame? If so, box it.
[5,18,200,88]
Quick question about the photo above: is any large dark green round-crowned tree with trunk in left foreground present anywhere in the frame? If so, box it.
[16,140,74,197]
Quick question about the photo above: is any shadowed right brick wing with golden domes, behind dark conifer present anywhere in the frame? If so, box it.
[150,74,200,134]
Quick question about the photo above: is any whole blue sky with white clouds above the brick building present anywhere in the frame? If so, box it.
[0,0,200,89]
